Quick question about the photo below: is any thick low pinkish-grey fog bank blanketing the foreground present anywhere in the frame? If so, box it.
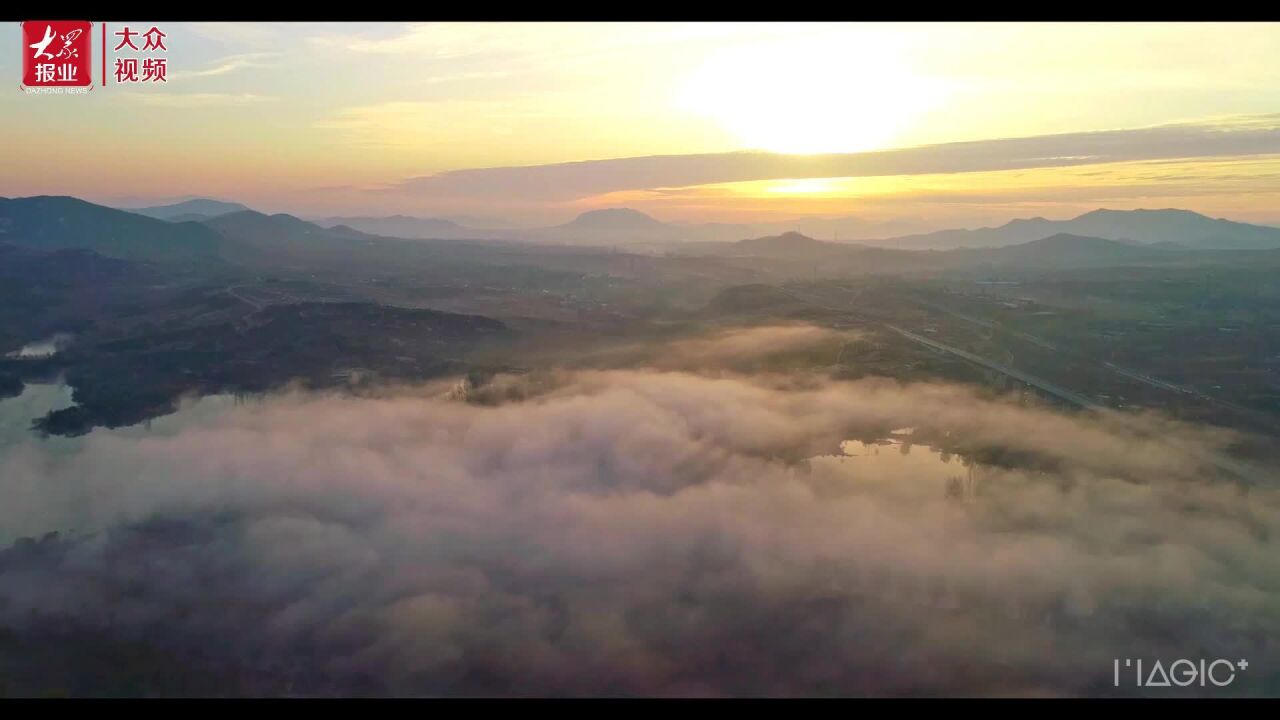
[0,345,1280,696]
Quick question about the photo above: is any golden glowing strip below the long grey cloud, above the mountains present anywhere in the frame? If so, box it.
[577,155,1280,223]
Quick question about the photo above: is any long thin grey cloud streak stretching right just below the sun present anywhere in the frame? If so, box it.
[388,115,1280,201]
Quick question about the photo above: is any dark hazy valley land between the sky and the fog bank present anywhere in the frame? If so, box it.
[0,199,1280,466]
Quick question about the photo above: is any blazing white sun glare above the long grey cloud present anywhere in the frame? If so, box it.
[676,36,946,154]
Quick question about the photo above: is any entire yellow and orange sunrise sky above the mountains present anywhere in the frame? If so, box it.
[0,20,1280,228]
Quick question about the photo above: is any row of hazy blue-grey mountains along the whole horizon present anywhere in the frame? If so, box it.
[10,196,1280,273]
